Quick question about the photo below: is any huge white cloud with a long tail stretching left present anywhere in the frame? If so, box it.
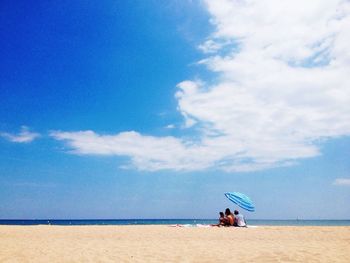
[52,0,350,172]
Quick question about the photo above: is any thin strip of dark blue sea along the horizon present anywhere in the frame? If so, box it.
[0,219,350,226]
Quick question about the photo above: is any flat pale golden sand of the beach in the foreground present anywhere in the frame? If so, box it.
[0,226,350,262]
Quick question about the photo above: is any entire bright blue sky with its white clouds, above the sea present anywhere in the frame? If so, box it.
[0,0,350,219]
